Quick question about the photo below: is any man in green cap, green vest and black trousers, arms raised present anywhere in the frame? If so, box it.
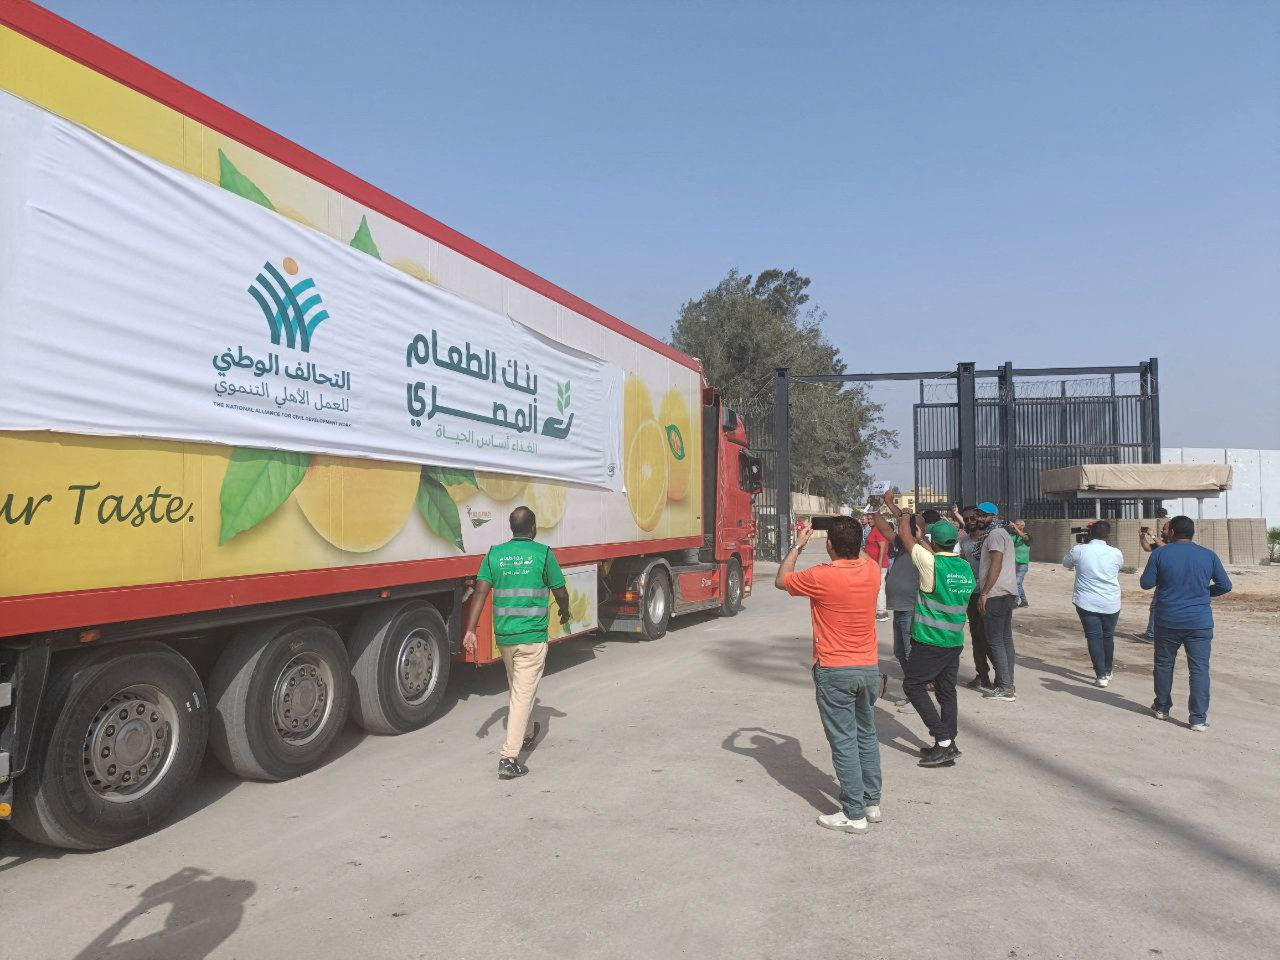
[874,492,977,767]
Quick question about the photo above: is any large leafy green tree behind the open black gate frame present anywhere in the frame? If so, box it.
[671,269,897,500]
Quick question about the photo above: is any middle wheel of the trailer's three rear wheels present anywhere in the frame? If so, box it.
[209,618,351,780]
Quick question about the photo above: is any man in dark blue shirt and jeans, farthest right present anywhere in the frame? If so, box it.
[1142,517,1231,732]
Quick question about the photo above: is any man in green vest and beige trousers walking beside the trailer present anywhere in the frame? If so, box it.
[462,507,570,780]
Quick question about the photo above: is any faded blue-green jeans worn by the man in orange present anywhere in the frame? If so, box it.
[813,664,881,820]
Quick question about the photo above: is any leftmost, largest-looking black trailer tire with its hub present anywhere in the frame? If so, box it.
[13,643,209,850]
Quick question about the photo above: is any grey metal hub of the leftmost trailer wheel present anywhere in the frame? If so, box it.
[83,687,174,803]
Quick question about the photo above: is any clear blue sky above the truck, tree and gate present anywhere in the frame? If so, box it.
[49,0,1280,481]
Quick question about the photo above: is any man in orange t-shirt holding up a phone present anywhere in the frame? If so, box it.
[773,517,881,833]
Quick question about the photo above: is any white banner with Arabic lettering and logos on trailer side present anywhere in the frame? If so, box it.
[0,93,622,490]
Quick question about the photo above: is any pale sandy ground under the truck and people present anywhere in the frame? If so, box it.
[0,564,1280,960]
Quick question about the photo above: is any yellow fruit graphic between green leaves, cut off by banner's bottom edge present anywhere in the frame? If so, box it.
[293,454,421,553]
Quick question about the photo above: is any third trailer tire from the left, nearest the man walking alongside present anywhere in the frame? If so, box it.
[347,600,451,735]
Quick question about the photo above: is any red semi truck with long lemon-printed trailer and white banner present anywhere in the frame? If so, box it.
[0,0,760,849]
